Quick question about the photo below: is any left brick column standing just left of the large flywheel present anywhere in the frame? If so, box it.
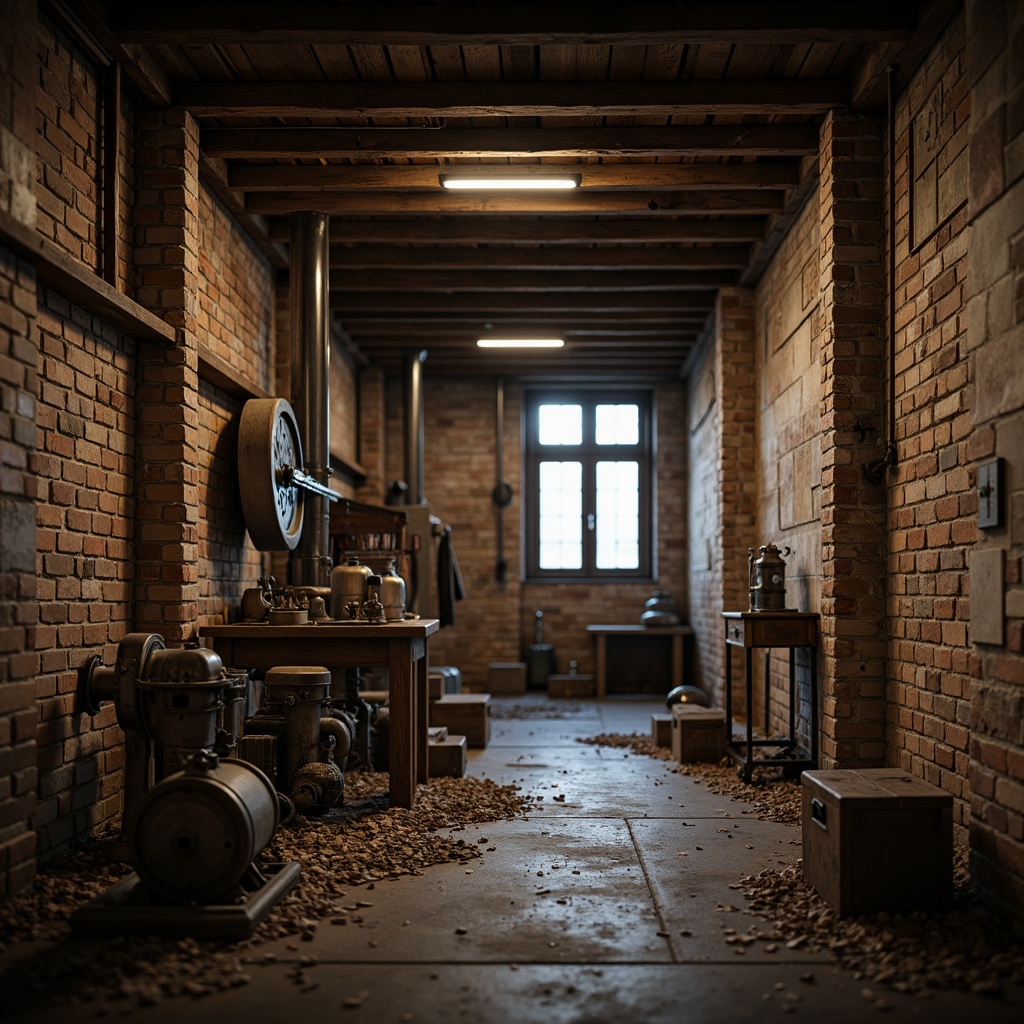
[134,111,199,643]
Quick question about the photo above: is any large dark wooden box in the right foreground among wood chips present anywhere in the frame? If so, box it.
[801,768,953,916]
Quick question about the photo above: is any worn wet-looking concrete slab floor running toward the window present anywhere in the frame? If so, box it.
[3,696,1024,1024]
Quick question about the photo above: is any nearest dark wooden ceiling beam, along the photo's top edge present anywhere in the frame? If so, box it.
[111,0,916,46]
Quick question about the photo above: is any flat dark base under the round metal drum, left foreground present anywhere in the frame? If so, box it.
[71,860,299,940]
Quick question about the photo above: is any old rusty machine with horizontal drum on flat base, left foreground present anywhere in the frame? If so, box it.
[73,633,299,938]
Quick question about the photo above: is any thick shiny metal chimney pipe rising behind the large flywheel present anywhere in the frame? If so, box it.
[289,212,331,587]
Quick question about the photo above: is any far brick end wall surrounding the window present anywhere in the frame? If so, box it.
[399,374,686,688]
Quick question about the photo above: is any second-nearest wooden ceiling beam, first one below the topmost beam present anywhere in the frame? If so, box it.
[180,78,851,120]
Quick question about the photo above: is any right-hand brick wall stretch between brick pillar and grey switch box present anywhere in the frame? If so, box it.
[886,18,977,822]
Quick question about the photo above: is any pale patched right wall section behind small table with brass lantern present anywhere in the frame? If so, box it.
[754,195,827,743]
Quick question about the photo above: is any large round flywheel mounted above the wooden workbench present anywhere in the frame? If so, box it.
[239,398,303,551]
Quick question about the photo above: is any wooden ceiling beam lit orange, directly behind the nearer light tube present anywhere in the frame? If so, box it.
[227,160,800,193]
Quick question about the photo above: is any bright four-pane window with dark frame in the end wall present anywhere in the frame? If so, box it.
[523,388,654,582]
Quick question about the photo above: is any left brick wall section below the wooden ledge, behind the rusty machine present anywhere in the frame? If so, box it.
[33,290,135,858]
